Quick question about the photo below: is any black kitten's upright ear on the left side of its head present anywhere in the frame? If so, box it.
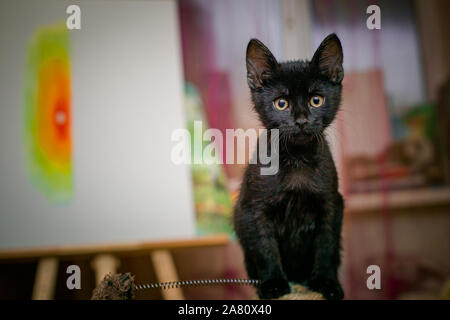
[246,39,278,89]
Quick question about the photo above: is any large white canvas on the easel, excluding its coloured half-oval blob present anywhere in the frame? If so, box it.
[0,0,195,249]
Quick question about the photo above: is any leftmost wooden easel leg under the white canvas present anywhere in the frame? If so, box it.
[31,258,59,300]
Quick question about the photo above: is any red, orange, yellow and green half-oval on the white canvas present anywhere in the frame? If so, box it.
[24,23,73,203]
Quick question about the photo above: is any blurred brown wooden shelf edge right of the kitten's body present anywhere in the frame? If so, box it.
[345,187,450,212]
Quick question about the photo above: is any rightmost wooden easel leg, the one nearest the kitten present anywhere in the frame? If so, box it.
[150,250,184,300]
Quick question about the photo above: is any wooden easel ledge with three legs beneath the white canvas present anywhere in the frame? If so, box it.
[0,235,229,300]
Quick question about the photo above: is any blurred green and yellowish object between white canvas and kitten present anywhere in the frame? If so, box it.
[185,83,233,235]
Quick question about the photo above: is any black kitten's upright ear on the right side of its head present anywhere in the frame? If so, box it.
[311,33,344,83]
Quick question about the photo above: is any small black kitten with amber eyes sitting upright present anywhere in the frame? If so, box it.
[234,34,344,299]
